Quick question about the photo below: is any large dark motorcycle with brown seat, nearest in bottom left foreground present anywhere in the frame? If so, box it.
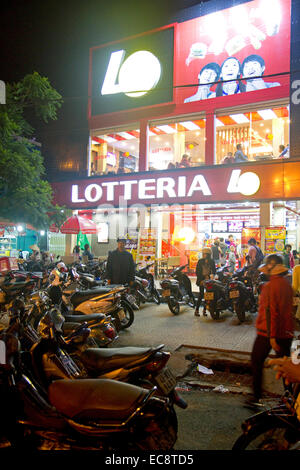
[0,309,177,451]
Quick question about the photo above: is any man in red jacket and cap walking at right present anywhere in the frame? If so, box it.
[247,255,294,407]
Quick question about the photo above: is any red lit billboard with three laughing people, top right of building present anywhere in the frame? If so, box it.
[175,0,291,103]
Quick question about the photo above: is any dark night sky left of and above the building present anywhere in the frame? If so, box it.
[0,0,204,174]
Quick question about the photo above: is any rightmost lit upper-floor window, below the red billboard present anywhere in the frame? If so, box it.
[215,106,289,164]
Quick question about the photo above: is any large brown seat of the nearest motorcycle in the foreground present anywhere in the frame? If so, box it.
[48,379,148,424]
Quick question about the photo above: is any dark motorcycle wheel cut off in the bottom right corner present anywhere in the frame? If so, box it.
[232,421,293,451]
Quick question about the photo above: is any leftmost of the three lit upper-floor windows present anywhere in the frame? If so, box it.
[89,125,140,176]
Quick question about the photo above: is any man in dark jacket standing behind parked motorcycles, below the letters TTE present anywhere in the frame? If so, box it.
[106,238,135,284]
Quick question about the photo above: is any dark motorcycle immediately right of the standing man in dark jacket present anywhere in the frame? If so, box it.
[132,263,160,306]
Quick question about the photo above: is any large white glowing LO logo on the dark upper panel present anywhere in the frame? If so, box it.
[101,50,161,98]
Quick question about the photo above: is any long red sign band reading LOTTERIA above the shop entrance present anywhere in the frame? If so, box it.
[52,161,300,209]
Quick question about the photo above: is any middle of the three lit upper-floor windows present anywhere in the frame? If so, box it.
[148,118,205,170]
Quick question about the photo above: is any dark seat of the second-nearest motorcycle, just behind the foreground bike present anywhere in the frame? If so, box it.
[80,346,153,373]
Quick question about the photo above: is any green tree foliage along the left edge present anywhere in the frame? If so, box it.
[0,72,63,228]
